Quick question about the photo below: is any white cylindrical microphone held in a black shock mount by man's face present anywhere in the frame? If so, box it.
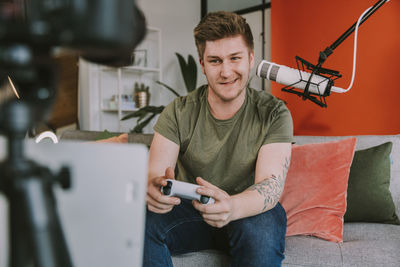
[256,60,347,97]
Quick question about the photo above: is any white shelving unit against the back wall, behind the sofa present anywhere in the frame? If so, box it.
[80,27,162,132]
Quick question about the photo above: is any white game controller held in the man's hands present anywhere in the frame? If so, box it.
[161,179,215,204]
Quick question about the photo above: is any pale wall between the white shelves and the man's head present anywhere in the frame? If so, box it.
[136,0,206,105]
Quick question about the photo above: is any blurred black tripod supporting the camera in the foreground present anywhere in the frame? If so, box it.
[0,69,72,267]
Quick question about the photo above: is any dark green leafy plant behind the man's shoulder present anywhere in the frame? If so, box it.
[121,53,197,133]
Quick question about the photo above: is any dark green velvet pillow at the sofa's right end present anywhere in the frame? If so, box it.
[344,142,400,224]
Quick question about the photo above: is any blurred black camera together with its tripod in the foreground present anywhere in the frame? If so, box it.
[0,0,146,267]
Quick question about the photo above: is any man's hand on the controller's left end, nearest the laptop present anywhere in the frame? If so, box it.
[147,167,181,213]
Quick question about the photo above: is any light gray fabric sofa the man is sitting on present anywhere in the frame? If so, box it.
[62,131,400,267]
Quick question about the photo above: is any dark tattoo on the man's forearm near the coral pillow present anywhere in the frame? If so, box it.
[247,156,290,212]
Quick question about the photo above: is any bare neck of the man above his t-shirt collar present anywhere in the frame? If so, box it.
[207,88,246,120]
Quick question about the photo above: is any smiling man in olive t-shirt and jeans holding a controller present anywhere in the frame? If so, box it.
[144,12,293,267]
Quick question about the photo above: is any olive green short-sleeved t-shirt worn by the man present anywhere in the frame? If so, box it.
[154,86,293,195]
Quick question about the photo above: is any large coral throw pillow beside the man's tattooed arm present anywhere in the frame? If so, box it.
[280,138,356,242]
